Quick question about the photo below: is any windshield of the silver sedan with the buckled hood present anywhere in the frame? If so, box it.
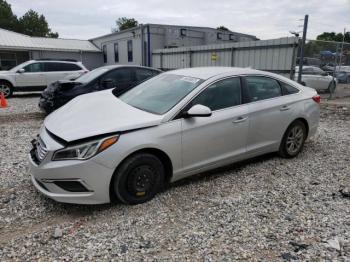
[119,74,204,115]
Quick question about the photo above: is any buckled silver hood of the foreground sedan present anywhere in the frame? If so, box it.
[44,90,162,142]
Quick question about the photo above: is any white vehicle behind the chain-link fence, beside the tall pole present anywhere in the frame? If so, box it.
[294,66,338,92]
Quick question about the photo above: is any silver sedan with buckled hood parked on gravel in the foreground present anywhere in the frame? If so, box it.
[29,67,320,204]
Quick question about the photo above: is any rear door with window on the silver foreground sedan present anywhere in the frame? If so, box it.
[245,76,297,154]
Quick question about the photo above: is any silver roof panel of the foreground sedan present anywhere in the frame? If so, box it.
[166,66,265,80]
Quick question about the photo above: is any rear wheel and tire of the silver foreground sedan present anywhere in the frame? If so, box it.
[278,120,307,158]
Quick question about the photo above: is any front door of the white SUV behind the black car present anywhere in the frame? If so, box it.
[16,62,46,91]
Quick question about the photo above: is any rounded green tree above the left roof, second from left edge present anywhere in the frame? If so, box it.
[18,10,58,38]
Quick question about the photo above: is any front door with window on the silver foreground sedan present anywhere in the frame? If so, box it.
[181,77,249,176]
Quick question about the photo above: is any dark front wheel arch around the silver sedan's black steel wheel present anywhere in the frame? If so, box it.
[109,147,173,202]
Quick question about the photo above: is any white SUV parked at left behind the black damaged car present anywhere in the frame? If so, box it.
[0,59,88,97]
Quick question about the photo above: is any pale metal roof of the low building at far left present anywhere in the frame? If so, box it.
[0,28,101,52]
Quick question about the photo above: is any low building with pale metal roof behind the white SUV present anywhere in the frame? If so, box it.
[0,28,103,70]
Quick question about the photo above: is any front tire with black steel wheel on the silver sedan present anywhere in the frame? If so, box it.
[112,153,165,205]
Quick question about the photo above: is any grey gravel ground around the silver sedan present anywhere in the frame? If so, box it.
[0,96,350,261]
